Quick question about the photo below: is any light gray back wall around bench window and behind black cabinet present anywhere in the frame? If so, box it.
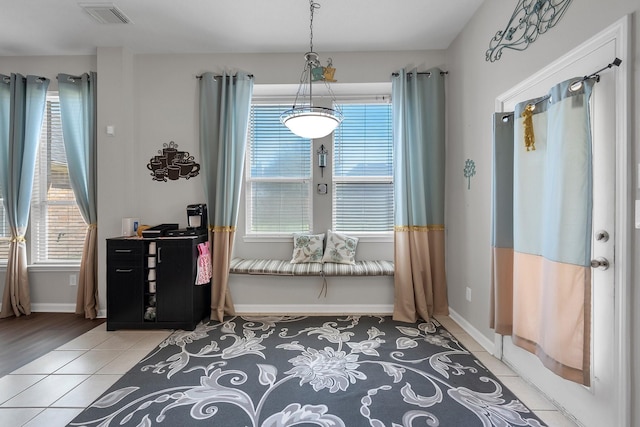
[98,48,445,312]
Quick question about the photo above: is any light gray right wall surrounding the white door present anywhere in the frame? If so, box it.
[446,0,640,425]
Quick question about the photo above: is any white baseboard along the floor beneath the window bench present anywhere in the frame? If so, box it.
[235,304,393,315]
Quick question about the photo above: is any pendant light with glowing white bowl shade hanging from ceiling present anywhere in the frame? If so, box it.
[280,0,342,139]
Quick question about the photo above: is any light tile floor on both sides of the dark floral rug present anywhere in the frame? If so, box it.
[0,317,576,427]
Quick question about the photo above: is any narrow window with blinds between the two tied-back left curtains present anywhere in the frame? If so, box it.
[30,93,87,263]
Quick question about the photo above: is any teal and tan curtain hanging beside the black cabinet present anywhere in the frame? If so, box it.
[200,73,253,321]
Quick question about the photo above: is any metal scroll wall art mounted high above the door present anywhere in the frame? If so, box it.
[485,0,571,62]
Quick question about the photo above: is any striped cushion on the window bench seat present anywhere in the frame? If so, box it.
[229,258,394,277]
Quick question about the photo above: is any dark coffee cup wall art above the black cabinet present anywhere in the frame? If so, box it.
[147,141,200,182]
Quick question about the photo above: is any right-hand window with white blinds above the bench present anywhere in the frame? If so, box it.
[332,103,393,233]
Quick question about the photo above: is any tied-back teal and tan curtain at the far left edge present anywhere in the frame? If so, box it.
[0,73,49,317]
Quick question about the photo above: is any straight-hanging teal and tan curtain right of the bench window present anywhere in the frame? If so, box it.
[391,68,448,322]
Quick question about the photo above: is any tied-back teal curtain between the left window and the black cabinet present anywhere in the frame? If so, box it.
[58,72,98,319]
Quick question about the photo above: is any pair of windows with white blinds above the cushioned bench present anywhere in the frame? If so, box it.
[245,102,394,236]
